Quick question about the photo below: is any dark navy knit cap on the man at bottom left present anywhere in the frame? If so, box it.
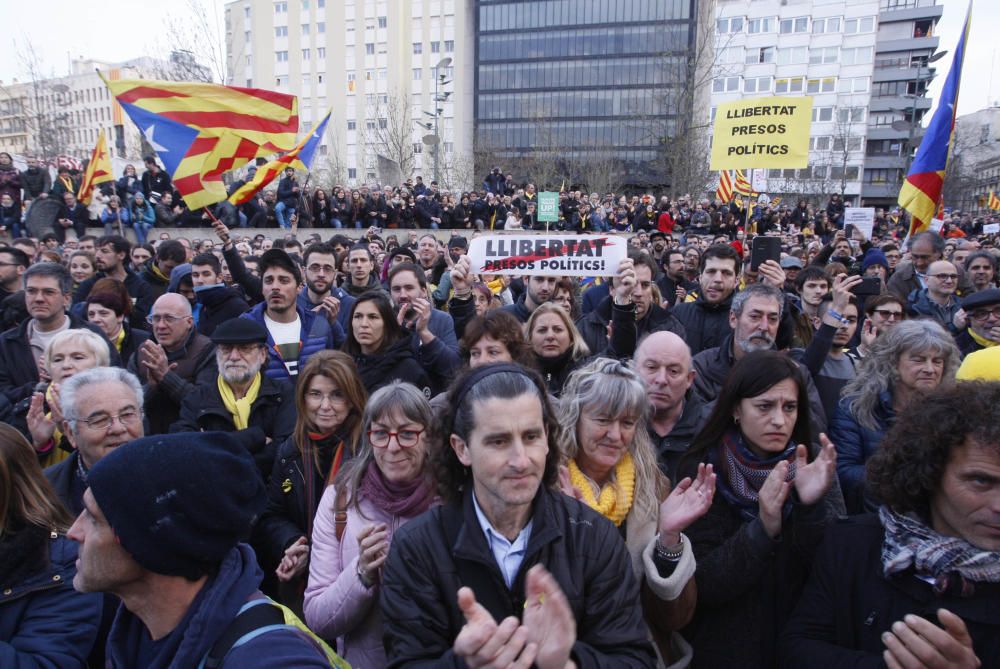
[87,432,266,579]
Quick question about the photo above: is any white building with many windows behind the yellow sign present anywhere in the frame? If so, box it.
[710,0,879,203]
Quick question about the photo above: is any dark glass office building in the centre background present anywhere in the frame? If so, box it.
[475,0,696,183]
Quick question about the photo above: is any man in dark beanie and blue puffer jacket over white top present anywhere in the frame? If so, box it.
[242,249,338,383]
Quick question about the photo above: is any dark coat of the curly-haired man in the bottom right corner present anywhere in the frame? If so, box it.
[780,514,1000,669]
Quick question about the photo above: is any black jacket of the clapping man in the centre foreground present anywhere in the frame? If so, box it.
[381,487,656,669]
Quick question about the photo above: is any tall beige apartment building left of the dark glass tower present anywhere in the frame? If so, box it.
[225,0,474,187]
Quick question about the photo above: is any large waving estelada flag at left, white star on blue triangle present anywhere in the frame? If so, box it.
[105,74,299,209]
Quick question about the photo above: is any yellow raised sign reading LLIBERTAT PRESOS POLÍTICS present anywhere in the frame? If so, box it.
[710,96,812,171]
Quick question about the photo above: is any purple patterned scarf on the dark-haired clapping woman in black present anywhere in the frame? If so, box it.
[711,429,795,520]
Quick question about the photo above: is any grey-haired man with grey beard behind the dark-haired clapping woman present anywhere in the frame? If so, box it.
[692,283,826,434]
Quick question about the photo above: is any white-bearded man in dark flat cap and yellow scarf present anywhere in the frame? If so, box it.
[170,318,295,481]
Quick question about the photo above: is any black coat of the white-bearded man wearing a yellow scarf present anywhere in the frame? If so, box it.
[170,372,295,482]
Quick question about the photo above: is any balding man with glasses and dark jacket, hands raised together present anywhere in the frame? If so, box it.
[128,293,215,434]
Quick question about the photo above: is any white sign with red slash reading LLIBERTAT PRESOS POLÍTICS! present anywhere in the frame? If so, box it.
[468,235,628,276]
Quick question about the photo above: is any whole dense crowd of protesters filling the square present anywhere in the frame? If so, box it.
[0,163,1000,669]
